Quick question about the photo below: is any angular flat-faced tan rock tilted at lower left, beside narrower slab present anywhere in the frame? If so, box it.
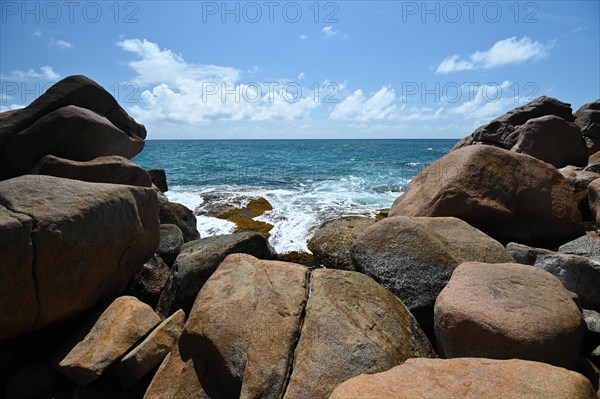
[57,296,160,386]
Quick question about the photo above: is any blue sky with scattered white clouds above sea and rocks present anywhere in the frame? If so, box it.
[0,0,600,139]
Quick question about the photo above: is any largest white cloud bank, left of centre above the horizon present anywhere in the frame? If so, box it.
[117,39,319,125]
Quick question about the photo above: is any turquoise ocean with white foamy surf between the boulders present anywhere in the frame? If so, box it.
[134,139,457,253]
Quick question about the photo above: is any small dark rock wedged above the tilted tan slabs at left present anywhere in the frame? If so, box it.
[127,255,169,308]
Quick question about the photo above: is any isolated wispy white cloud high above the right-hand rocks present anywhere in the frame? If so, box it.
[436,36,552,73]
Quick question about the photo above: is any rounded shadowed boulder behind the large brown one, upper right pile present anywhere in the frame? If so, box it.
[511,115,587,168]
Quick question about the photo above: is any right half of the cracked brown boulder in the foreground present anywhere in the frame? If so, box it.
[283,269,436,399]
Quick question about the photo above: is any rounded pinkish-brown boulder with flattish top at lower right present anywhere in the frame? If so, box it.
[435,262,584,368]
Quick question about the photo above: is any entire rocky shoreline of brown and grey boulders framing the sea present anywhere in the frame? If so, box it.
[0,76,600,399]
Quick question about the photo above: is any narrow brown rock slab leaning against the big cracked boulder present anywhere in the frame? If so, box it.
[115,310,185,387]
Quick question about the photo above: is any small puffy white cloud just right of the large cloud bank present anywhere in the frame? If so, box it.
[330,87,397,121]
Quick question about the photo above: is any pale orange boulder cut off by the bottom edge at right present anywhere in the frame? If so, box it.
[330,358,597,399]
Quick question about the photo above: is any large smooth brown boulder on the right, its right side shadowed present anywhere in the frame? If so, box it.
[390,145,584,247]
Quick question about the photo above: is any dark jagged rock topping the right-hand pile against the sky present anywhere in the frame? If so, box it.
[453,96,575,150]
